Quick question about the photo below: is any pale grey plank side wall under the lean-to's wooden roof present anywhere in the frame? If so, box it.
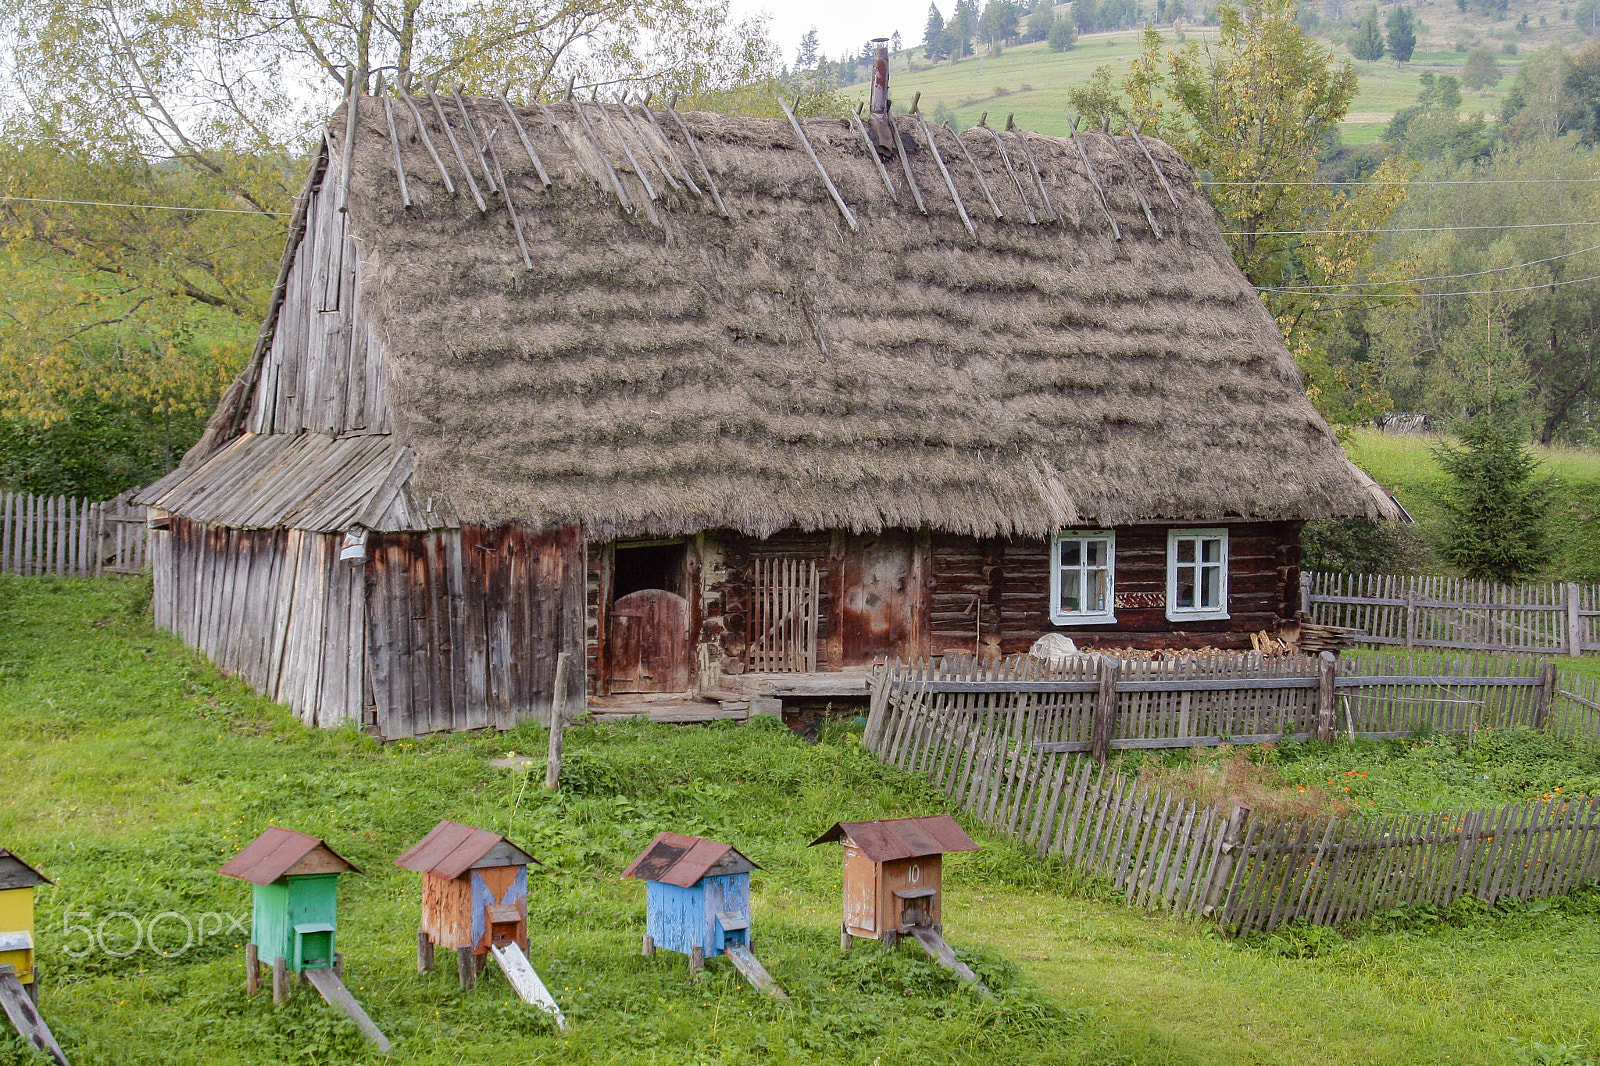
[150,517,366,725]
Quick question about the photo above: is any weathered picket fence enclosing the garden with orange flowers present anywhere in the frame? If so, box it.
[864,656,1600,933]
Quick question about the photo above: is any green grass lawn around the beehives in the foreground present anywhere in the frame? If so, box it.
[0,578,1600,1066]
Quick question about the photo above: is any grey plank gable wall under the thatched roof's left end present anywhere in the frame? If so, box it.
[246,160,390,434]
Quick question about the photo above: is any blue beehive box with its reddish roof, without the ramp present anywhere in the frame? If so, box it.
[622,832,755,972]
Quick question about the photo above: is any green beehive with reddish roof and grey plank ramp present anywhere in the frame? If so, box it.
[218,826,390,1052]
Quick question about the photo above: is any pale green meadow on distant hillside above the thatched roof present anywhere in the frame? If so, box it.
[846,27,1518,144]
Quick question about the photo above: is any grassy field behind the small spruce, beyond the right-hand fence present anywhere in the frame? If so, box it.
[1344,429,1600,583]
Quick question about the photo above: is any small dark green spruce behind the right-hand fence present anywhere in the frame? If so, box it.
[1437,410,1554,581]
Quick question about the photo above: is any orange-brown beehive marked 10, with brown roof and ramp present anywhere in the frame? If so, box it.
[810,815,989,992]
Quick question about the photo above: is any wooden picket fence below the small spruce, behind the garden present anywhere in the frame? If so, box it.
[1301,571,1600,655]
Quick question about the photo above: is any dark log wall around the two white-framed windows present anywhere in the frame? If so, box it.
[930,522,1299,655]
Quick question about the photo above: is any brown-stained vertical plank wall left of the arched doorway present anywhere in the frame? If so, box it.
[366,527,586,738]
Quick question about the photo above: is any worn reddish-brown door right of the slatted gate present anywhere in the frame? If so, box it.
[837,530,918,666]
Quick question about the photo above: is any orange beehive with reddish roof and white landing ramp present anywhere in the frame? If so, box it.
[395,820,566,1029]
